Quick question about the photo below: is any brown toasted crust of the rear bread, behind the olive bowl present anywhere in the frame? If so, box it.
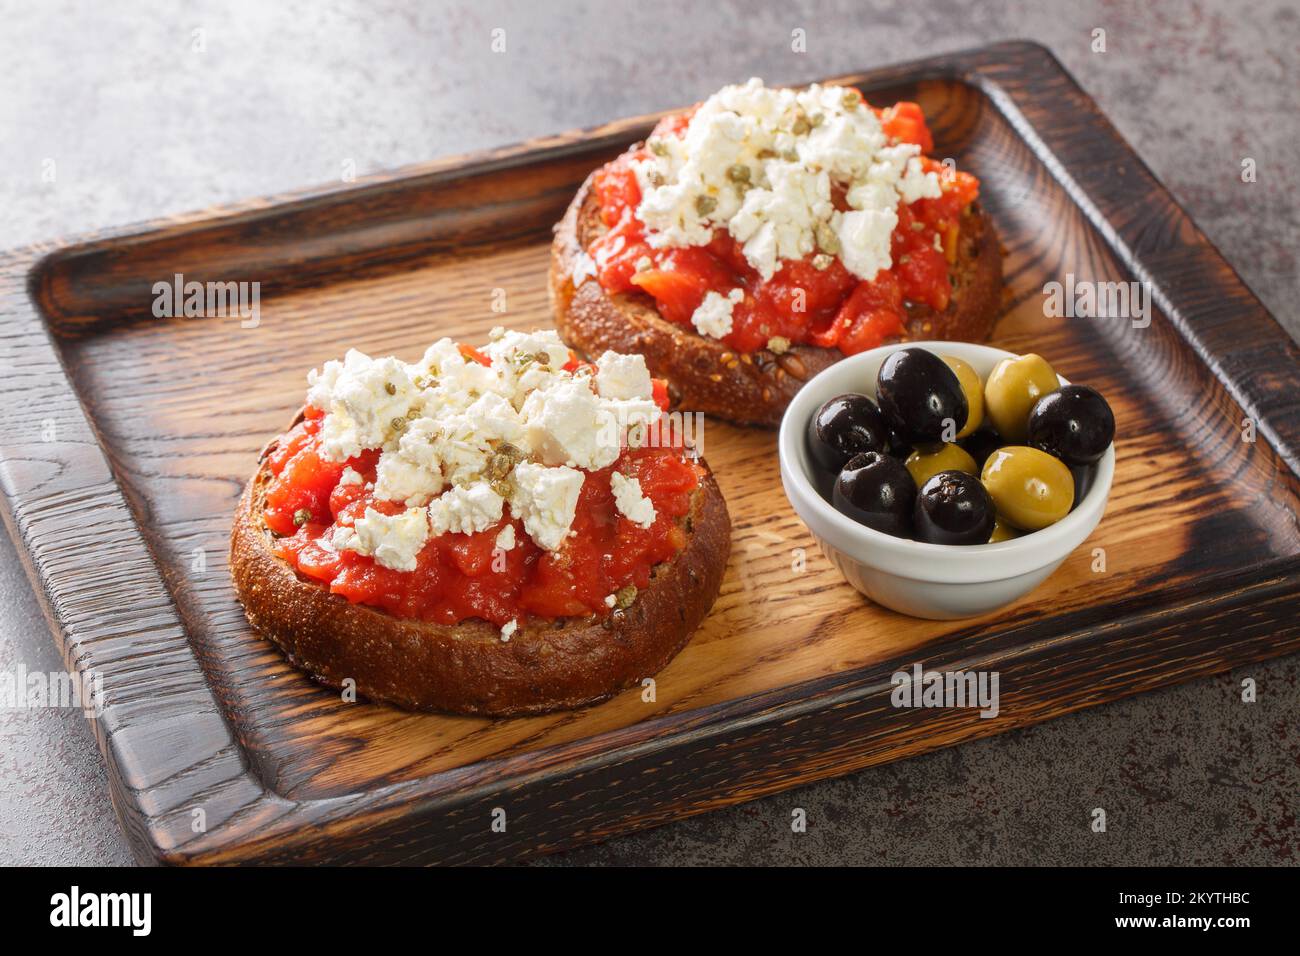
[550,167,1002,425]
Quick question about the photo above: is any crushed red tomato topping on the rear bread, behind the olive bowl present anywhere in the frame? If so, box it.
[588,96,979,355]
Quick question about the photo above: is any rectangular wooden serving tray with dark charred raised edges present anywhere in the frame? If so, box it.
[0,43,1300,862]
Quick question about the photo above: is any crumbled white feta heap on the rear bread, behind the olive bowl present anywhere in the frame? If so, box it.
[629,79,940,280]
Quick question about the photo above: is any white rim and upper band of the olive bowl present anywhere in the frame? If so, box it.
[777,341,1115,583]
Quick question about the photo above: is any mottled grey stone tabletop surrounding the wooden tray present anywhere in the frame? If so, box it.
[0,0,1300,865]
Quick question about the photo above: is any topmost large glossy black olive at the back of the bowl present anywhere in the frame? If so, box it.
[876,349,970,445]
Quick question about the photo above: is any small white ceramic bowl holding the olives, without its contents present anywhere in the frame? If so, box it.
[777,342,1115,620]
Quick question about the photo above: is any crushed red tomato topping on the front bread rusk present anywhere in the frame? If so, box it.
[264,395,703,626]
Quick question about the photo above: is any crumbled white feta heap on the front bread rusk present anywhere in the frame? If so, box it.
[308,329,662,554]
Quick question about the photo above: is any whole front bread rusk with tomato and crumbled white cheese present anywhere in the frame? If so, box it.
[230,330,731,717]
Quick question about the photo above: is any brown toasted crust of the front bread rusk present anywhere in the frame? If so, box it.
[230,453,731,717]
